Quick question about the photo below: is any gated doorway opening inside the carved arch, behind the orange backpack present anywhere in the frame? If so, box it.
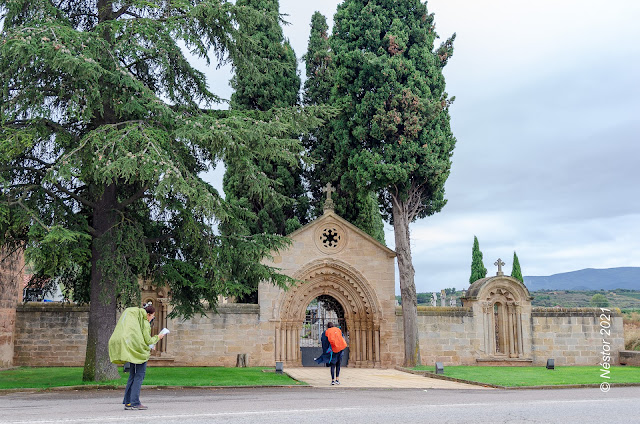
[300,294,349,367]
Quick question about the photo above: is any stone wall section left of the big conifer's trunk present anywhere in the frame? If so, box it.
[13,302,89,367]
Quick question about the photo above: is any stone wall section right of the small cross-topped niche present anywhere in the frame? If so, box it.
[531,308,624,365]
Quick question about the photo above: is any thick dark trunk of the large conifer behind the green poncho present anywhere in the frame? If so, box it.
[82,184,120,381]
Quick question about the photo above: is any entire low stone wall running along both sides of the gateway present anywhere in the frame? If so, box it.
[13,303,624,367]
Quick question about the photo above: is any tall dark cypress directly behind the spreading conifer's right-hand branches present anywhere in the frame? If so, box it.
[223,0,309,235]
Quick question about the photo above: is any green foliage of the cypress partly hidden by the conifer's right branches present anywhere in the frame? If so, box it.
[220,0,309,302]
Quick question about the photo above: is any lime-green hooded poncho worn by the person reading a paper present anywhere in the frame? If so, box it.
[109,307,159,364]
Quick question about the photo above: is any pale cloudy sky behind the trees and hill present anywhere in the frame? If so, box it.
[198,0,640,292]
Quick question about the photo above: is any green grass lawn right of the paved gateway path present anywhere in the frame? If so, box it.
[414,366,640,387]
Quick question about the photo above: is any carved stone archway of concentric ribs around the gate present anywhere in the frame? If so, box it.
[275,258,381,367]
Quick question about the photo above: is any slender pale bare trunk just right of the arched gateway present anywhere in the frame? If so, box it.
[392,199,420,367]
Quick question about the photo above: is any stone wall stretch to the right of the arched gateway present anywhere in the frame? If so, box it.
[391,307,624,366]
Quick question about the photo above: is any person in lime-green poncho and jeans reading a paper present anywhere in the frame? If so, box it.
[109,305,164,410]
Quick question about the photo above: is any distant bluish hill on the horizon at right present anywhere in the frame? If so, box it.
[524,267,640,291]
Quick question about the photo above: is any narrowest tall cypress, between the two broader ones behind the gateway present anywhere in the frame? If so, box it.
[303,12,384,243]
